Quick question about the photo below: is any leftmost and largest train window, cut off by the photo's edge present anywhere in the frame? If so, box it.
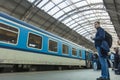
[0,23,18,44]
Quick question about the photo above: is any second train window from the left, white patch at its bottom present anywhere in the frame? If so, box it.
[28,33,42,49]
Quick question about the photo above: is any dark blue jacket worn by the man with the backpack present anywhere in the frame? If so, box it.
[93,27,109,52]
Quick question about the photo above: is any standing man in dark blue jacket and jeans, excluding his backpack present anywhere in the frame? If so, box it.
[91,21,110,80]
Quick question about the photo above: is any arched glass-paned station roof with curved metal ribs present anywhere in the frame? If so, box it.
[28,0,118,47]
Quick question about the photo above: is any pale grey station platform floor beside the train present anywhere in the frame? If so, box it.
[0,69,120,80]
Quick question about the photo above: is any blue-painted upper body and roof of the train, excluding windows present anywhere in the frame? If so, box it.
[0,13,93,60]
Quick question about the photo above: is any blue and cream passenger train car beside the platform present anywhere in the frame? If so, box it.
[0,12,92,71]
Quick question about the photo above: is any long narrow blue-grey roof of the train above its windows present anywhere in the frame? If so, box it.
[0,12,85,49]
